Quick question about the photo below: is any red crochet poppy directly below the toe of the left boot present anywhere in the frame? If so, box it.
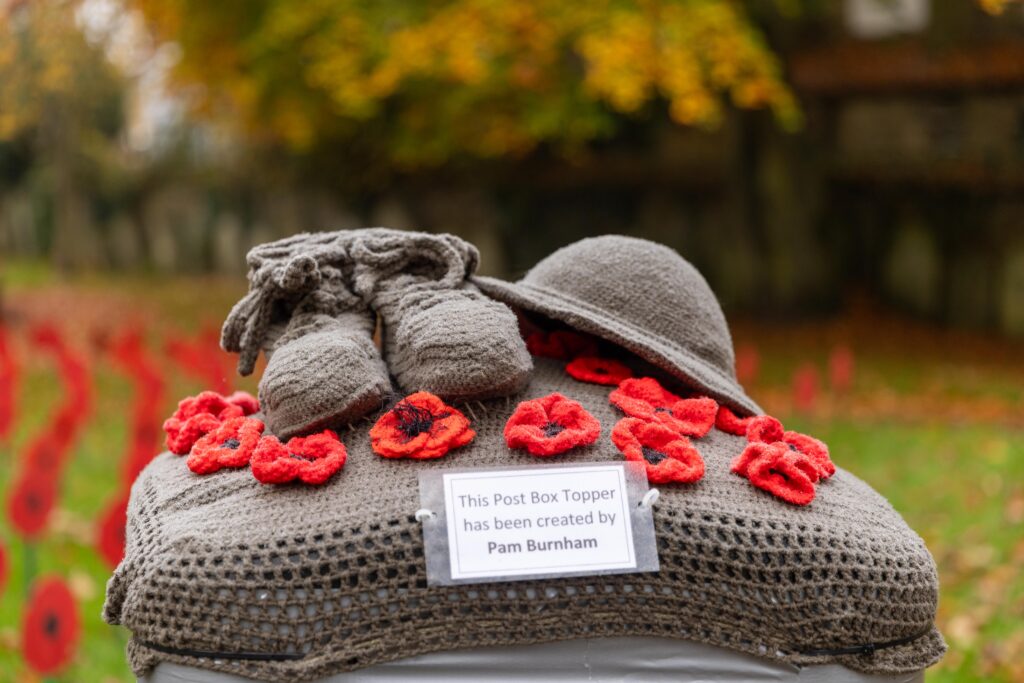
[252,429,347,484]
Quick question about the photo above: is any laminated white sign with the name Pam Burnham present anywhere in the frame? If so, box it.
[421,463,657,583]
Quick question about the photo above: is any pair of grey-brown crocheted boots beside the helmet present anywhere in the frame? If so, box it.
[221,227,531,411]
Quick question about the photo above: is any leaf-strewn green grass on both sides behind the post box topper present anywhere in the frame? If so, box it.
[0,267,1024,683]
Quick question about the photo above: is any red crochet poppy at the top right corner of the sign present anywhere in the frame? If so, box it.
[611,418,705,483]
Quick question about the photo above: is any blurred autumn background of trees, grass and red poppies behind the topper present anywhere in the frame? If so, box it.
[0,0,1024,683]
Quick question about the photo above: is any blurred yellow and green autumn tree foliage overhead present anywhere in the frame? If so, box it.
[132,0,799,167]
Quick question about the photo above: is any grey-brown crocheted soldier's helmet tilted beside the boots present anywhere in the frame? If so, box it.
[472,234,761,414]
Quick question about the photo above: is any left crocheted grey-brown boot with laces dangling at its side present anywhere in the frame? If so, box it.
[221,233,390,438]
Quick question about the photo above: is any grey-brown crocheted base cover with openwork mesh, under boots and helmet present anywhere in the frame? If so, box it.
[104,358,945,682]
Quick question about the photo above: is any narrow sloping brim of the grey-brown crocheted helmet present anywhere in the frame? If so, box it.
[471,275,764,415]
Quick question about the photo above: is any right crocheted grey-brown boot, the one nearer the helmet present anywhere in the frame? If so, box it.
[348,228,532,400]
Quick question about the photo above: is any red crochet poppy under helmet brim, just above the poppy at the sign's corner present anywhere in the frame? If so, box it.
[608,377,718,437]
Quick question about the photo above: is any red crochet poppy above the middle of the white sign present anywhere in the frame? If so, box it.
[505,392,601,456]
